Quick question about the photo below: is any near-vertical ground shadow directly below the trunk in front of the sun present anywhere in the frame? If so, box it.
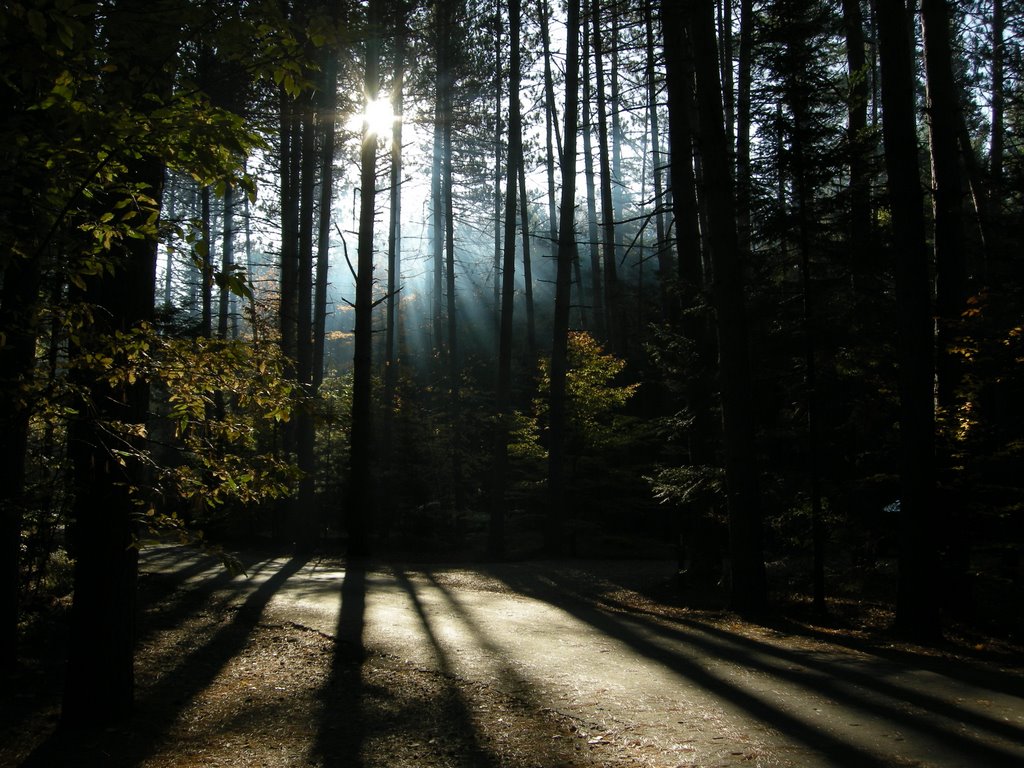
[313,561,368,768]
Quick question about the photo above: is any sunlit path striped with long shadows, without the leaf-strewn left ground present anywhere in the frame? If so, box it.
[121,550,1024,768]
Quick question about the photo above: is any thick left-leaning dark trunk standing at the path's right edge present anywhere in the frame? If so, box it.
[684,0,767,612]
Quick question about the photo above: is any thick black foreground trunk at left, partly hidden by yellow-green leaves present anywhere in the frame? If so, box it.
[61,0,177,727]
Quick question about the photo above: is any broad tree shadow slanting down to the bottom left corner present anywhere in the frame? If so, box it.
[23,557,307,768]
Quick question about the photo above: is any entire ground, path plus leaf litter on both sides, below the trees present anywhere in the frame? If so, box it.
[0,547,1024,768]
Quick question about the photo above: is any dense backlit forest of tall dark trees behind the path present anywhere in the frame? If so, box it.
[0,0,1024,749]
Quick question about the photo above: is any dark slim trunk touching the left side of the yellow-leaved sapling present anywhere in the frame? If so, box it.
[546,0,577,552]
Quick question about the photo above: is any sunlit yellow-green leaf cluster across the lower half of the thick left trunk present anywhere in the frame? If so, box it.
[67,325,296,531]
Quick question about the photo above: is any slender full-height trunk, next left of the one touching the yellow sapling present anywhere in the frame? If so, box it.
[487,0,525,557]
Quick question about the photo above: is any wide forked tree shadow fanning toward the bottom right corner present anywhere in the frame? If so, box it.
[486,570,1021,768]
